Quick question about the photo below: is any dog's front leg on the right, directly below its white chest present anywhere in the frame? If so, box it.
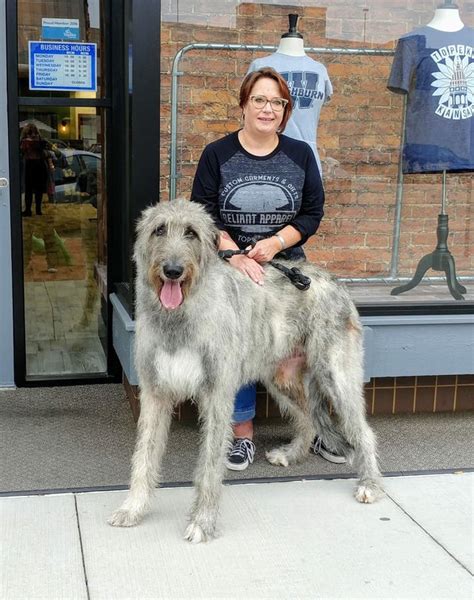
[184,393,234,543]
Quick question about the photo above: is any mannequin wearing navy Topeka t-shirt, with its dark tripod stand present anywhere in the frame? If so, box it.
[387,0,474,300]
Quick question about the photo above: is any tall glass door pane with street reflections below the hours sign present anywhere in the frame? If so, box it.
[19,107,107,376]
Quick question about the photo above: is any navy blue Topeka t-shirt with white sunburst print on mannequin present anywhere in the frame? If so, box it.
[387,26,474,173]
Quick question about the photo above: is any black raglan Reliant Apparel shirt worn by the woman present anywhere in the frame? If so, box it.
[191,132,324,259]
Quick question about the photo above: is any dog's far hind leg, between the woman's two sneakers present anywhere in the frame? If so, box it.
[265,380,315,467]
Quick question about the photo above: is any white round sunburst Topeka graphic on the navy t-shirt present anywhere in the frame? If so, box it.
[431,44,474,120]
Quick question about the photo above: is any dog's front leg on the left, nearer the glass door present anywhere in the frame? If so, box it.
[108,391,173,527]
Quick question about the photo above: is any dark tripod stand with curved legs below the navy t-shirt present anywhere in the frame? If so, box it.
[391,171,467,300]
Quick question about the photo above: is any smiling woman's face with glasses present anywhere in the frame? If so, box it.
[243,77,285,135]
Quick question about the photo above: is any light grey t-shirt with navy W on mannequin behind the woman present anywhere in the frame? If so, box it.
[248,52,332,172]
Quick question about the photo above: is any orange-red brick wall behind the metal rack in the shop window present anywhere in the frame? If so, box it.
[161,0,474,276]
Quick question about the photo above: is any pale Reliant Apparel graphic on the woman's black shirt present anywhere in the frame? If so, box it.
[220,175,298,243]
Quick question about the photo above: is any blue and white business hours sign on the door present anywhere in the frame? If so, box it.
[28,42,97,92]
